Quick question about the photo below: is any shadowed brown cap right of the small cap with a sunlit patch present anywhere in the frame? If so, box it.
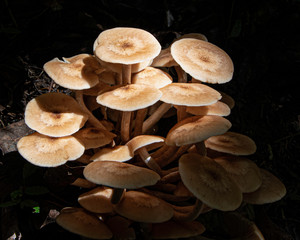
[115,191,174,223]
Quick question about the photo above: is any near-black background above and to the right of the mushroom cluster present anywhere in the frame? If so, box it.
[0,0,300,239]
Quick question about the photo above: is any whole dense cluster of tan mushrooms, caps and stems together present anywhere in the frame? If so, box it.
[17,27,286,239]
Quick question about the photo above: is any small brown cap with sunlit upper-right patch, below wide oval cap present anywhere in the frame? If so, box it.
[78,186,113,213]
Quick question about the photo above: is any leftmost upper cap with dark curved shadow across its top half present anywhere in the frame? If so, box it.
[25,92,88,137]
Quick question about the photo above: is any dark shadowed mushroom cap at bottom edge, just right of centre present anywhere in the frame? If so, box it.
[151,220,205,239]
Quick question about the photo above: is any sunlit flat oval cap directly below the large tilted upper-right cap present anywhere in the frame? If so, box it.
[160,83,221,106]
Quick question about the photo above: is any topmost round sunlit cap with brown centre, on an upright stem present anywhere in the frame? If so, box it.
[94,27,161,64]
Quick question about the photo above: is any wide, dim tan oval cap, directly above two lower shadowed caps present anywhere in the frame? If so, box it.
[83,161,160,189]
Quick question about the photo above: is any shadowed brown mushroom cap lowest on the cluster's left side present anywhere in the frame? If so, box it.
[56,207,112,239]
